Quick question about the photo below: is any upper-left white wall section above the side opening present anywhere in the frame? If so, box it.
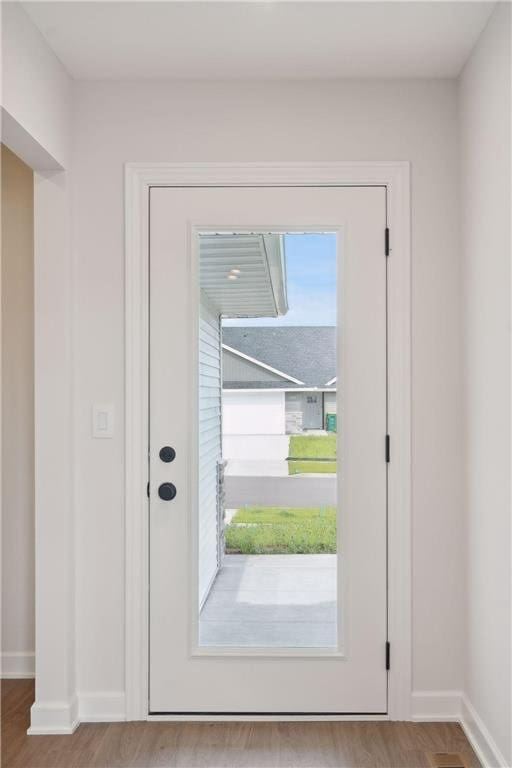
[1,2,72,170]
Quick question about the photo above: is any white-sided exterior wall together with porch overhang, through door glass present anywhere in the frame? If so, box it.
[198,234,288,604]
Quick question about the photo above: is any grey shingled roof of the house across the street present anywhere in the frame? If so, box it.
[222,325,336,389]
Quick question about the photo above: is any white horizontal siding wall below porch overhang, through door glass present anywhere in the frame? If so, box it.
[198,301,222,604]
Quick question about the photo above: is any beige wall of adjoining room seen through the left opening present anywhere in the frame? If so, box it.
[1,146,34,674]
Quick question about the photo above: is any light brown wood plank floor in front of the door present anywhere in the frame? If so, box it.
[1,680,480,768]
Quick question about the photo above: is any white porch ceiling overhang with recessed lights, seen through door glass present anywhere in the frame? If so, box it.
[199,233,288,317]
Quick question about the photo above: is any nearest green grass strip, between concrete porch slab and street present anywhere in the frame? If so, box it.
[226,507,336,555]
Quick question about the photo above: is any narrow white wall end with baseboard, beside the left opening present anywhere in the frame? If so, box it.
[31,168,74,733]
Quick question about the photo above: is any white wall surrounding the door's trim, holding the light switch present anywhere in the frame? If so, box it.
[72,80,465,704]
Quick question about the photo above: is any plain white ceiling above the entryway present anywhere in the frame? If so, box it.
[23,0,494,80]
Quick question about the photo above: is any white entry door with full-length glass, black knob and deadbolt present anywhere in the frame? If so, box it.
[149,187,387,716]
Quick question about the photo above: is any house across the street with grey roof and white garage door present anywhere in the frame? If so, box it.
[222,326,336,458]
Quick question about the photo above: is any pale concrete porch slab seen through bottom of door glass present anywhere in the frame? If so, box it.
[199,555,337,649]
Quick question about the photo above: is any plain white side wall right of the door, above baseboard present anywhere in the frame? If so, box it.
[459,3,512,765]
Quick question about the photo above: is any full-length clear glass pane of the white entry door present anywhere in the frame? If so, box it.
[197,232,340,650]
